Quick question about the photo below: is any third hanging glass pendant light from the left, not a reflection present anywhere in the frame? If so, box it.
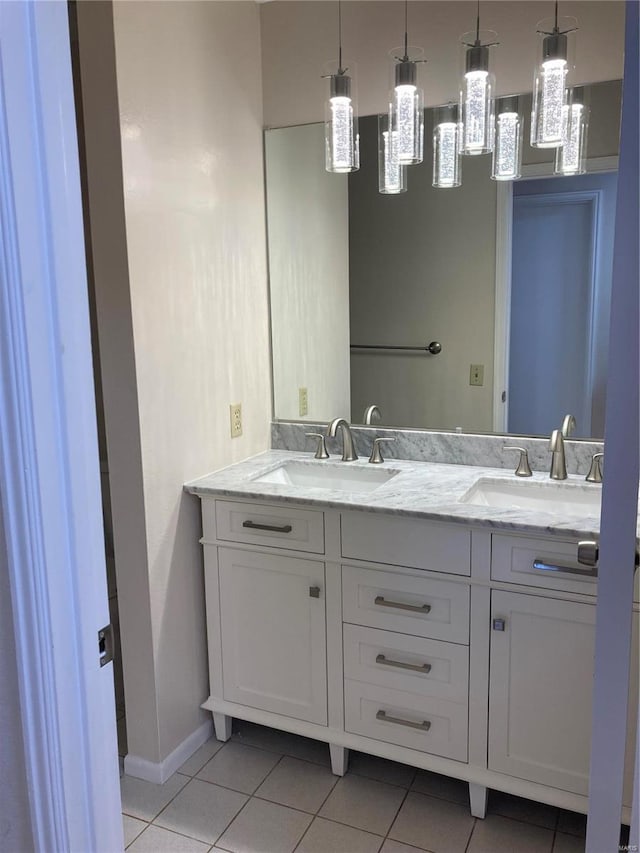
[460,0,497,154]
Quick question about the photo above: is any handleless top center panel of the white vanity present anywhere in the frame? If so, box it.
[342,512,471,575]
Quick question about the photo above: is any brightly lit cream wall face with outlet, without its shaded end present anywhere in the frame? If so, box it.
[114,2,271,757]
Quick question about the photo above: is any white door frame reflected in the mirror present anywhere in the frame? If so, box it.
[493,157,619,433]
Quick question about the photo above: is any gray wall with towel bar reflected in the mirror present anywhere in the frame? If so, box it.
[349,111,496,431]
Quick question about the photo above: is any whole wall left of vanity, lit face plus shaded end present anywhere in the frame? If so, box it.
[78,0,271,763]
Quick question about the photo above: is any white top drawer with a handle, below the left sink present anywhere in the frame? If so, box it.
[209,501,324,554]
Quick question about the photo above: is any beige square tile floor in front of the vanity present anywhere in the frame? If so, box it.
[121,722,620,853]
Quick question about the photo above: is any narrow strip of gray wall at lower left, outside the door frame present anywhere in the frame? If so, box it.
[0,513,34,853]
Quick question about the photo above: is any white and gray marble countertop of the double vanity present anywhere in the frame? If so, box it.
[185,450,620,538]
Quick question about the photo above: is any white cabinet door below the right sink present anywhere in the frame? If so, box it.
[489,590,638,800]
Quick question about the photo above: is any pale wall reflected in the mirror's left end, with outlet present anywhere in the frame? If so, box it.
[265,124,351,422]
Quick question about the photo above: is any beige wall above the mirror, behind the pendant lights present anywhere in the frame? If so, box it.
[261,0,624,127]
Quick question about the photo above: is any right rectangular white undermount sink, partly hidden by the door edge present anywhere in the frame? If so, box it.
[460,477,602,516]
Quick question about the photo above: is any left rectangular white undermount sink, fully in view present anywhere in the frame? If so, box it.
[253,462,400,492]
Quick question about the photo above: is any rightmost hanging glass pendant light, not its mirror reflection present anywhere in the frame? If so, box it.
[531,0,577,148]
